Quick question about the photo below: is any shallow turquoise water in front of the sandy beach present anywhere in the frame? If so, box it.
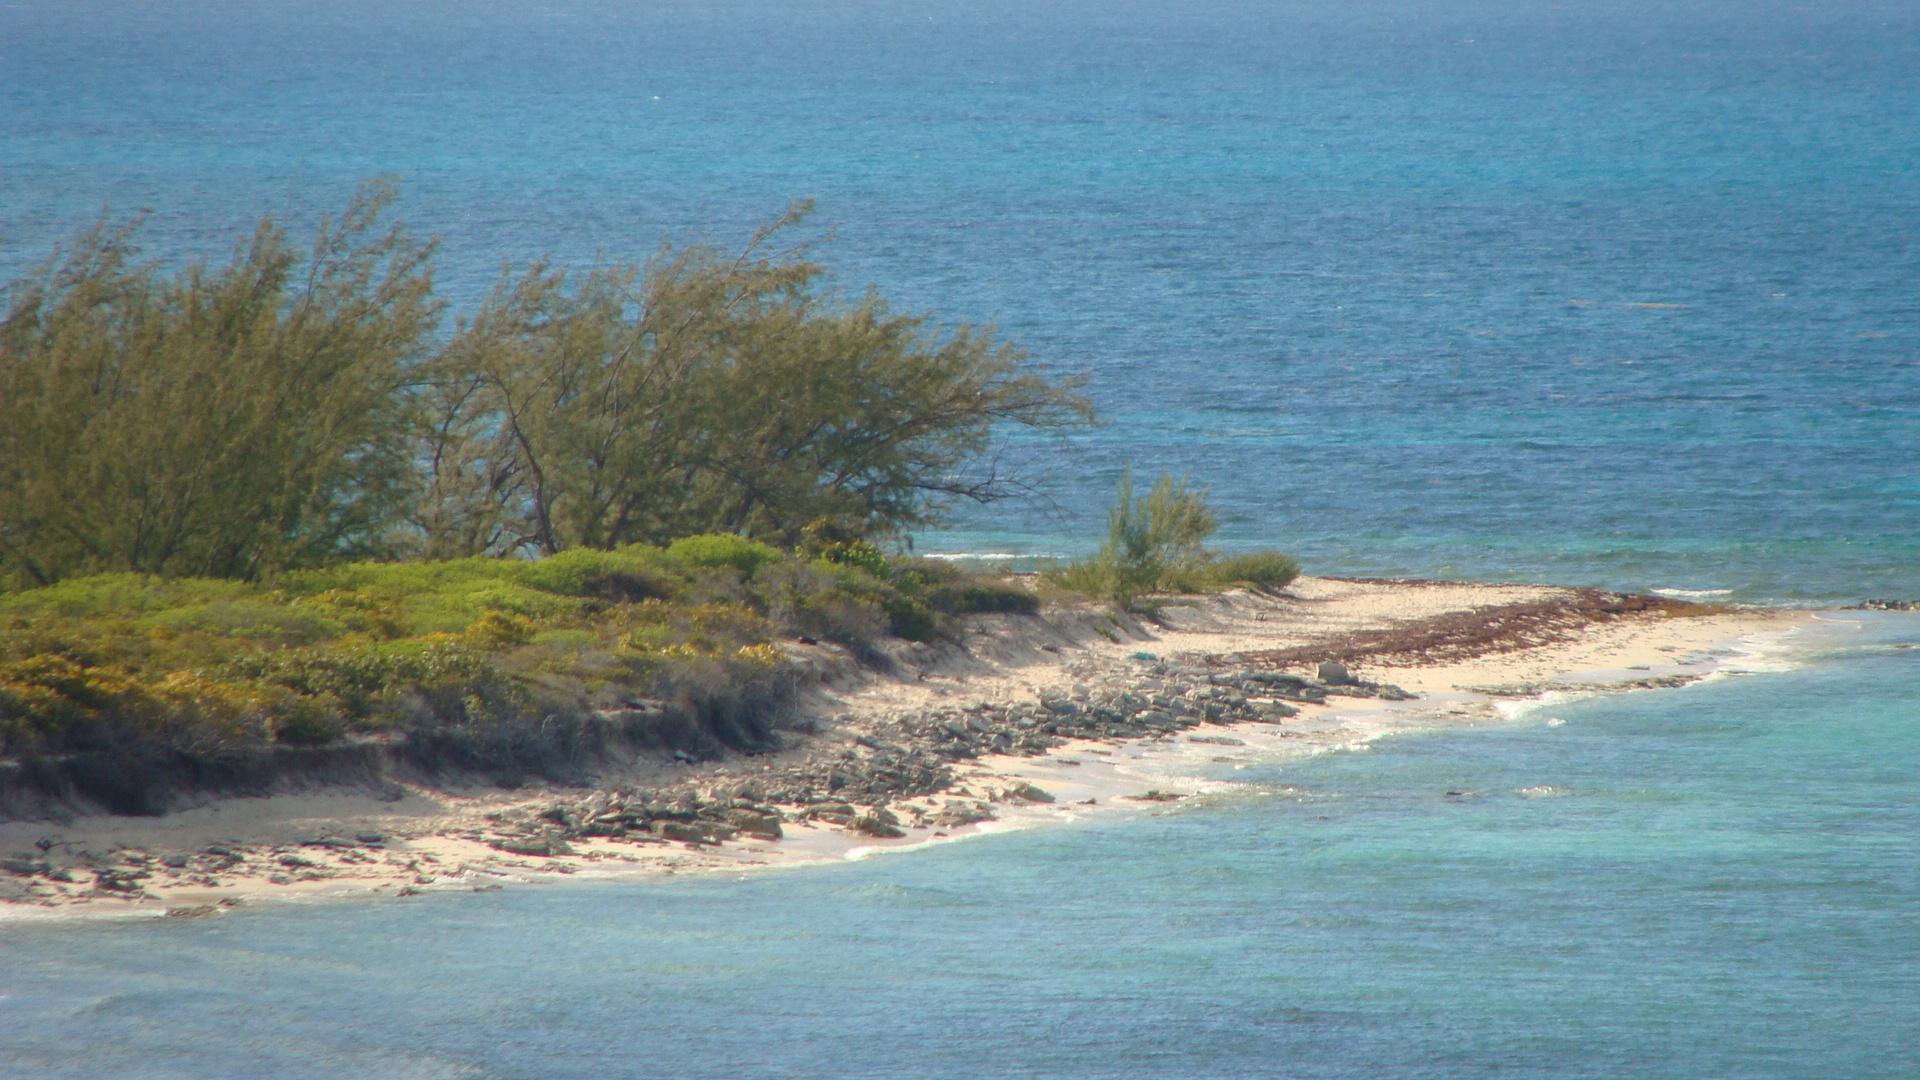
[0,617,1920,1080]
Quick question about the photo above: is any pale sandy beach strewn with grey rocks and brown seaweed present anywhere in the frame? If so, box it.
[0,578,1811,919]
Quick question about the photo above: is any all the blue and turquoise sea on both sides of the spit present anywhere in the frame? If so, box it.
[0,0,1920,1078]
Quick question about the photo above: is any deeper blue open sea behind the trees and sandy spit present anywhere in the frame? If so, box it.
[0,0,1920,601]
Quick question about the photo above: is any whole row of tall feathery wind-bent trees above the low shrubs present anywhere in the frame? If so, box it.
[0,183,1091,588]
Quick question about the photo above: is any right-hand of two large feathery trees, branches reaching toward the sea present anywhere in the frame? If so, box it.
[417,204,1091,555]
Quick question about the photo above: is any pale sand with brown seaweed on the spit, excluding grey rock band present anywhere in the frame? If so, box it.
[0,578,1812,920]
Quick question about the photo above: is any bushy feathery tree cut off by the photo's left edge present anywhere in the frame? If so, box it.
[0,183,438,584]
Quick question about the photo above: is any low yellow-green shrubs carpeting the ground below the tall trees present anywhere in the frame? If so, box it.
[0,534,1037,769]
